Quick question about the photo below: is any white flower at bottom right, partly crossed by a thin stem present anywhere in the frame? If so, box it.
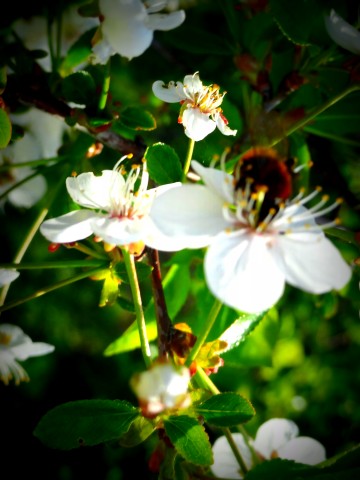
[211,418,326,479]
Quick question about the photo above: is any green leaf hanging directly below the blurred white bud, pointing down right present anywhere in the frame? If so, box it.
[164,415,213,465]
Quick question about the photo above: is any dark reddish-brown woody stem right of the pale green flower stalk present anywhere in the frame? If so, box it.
[147,247,172,358]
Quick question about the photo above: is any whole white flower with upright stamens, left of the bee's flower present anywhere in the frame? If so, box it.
[40,156,181,249]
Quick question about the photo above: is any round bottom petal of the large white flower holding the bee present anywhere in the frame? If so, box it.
[205,231,285,313]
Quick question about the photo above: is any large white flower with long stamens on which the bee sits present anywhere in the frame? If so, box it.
[150,161,351,313]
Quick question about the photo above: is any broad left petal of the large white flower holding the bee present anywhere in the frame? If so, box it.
[150,185,228,251]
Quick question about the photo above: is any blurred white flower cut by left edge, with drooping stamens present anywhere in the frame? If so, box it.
[0,323,55,385]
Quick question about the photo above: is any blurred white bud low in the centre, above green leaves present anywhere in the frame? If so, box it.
[131,362,190,417]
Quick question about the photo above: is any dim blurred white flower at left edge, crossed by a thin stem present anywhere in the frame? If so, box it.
[0,109,69,208]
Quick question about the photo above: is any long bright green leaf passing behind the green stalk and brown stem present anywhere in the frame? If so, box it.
[104,264,190,356]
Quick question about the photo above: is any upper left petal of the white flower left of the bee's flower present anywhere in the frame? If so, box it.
[66,170,121,211]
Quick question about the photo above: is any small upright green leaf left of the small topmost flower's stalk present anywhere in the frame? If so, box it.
[145,143,182,185]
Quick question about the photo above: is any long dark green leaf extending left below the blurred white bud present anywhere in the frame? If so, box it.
[34,400,139,450]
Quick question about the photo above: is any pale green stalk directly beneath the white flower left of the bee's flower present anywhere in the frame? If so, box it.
[121,247,151,367]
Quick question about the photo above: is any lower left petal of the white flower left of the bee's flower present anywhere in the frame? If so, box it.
[40,210,96,243]
